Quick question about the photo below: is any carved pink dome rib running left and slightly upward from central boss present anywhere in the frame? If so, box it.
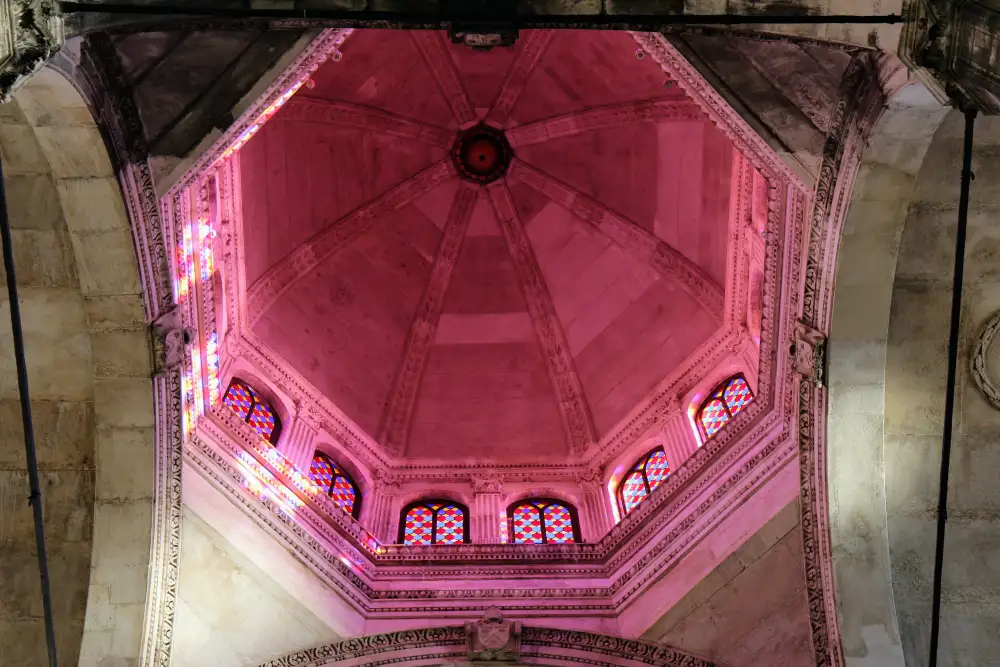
[275,97,454,149]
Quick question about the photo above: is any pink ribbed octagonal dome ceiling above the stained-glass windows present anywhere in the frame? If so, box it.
[239,31,734,460]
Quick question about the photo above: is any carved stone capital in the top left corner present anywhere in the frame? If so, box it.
[0,0,63,102]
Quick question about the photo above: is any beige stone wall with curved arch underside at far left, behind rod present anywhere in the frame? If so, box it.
[0,70,153,667]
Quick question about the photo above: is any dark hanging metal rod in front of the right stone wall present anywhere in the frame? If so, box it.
[929,109,976,667]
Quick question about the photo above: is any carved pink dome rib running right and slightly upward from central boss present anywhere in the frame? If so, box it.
[507,96,704,148]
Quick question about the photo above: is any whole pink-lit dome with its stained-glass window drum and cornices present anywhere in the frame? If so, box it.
[163,24,807,637]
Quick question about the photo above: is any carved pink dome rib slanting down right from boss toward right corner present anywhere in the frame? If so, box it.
[507,159,725,320]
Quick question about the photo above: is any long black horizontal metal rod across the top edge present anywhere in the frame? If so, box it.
[59,2,903,30]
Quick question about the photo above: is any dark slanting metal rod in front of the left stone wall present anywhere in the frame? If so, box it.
[0,144,56,667]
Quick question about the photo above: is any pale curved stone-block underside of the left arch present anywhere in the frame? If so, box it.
[9,67,159,661]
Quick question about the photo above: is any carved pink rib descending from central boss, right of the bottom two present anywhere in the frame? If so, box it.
[487,181,597,455]
